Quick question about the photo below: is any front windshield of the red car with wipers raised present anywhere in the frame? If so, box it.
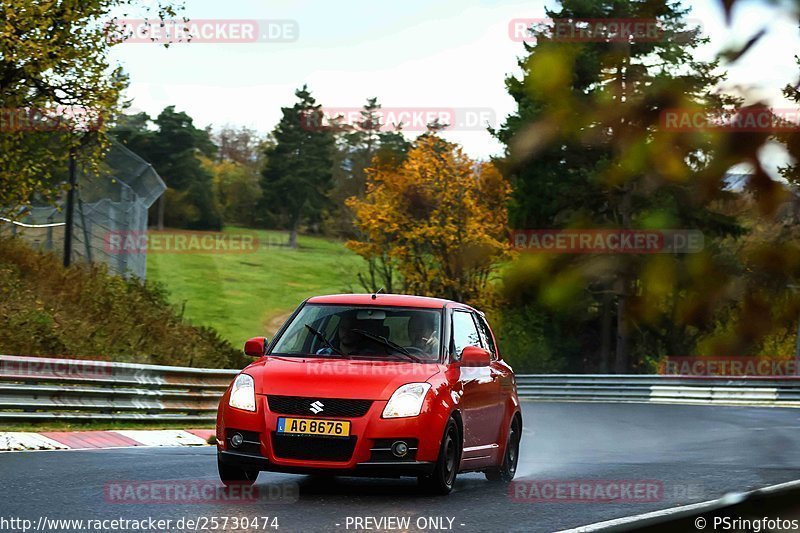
[270,304,442,363]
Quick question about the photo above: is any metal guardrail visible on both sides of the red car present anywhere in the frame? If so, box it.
[0,355,800,422]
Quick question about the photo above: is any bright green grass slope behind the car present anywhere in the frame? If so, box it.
[147,228,366,346]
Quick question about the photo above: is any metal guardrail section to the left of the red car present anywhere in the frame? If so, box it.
[0,355,238,422]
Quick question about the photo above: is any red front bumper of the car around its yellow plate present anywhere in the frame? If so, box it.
[217,395,447,477]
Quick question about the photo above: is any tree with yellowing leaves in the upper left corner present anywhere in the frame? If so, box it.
[0,0,181,217]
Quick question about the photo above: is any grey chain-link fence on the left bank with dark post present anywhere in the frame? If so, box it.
[0,142,167,279]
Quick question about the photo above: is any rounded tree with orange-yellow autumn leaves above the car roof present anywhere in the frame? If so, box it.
[347,134,511,305]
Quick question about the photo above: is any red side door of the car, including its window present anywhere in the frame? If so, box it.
[451,309,497,464]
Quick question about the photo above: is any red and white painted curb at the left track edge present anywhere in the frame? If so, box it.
[0,429,214,452]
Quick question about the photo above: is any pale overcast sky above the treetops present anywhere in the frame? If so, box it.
[111,0,800,159]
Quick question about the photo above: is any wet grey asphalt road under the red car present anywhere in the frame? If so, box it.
[0,402,800,532]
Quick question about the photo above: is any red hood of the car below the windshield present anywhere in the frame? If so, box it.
[243,356,442,400]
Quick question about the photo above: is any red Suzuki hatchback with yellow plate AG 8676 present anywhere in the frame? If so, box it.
[217,294,522,494]
